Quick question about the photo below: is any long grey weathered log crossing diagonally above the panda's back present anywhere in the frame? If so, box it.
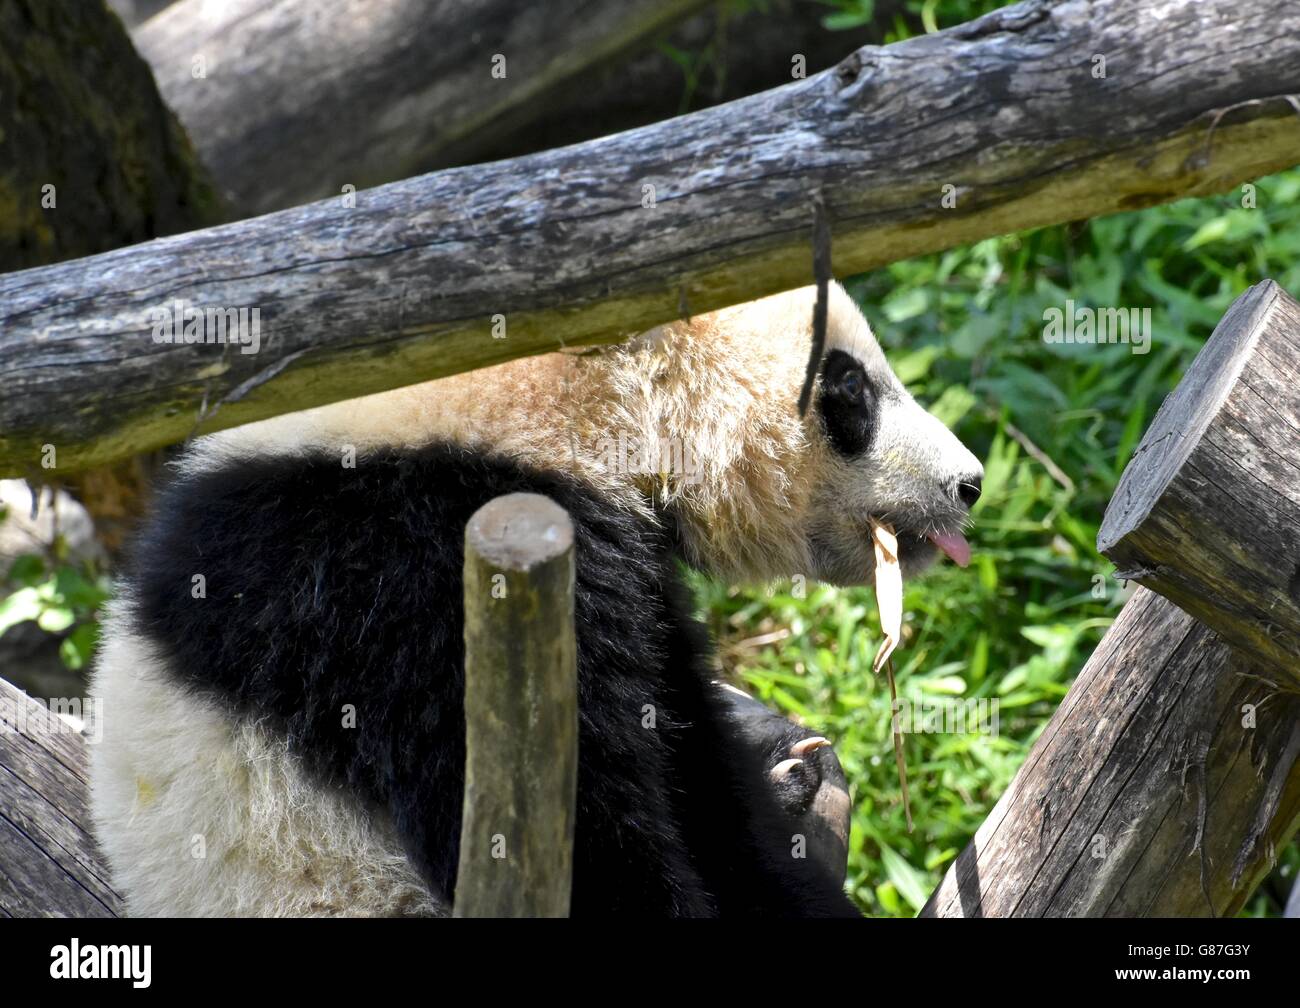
[0,0,1300,475]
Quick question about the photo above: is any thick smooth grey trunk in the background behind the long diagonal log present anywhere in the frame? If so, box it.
[137,0,904,205]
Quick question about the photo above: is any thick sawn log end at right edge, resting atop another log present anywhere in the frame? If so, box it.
[1097,281,1300,692]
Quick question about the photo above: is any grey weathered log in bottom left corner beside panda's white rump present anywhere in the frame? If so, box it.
[0,679,122,917]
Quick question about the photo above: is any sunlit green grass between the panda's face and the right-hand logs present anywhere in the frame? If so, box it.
[696,170,1300,916]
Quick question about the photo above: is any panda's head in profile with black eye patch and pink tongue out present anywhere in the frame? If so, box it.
[624,284,983,585]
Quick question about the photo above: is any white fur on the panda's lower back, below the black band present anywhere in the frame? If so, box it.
[90,598,447,917]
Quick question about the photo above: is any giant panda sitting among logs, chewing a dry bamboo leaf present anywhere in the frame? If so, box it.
[91,285,982,917]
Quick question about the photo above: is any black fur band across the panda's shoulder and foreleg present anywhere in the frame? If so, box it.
[129,444,855,916]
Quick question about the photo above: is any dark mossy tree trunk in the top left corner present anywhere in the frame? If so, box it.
[0,0,220,272]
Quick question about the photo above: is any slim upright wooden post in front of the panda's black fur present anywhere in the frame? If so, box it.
[454,493,577,917]
